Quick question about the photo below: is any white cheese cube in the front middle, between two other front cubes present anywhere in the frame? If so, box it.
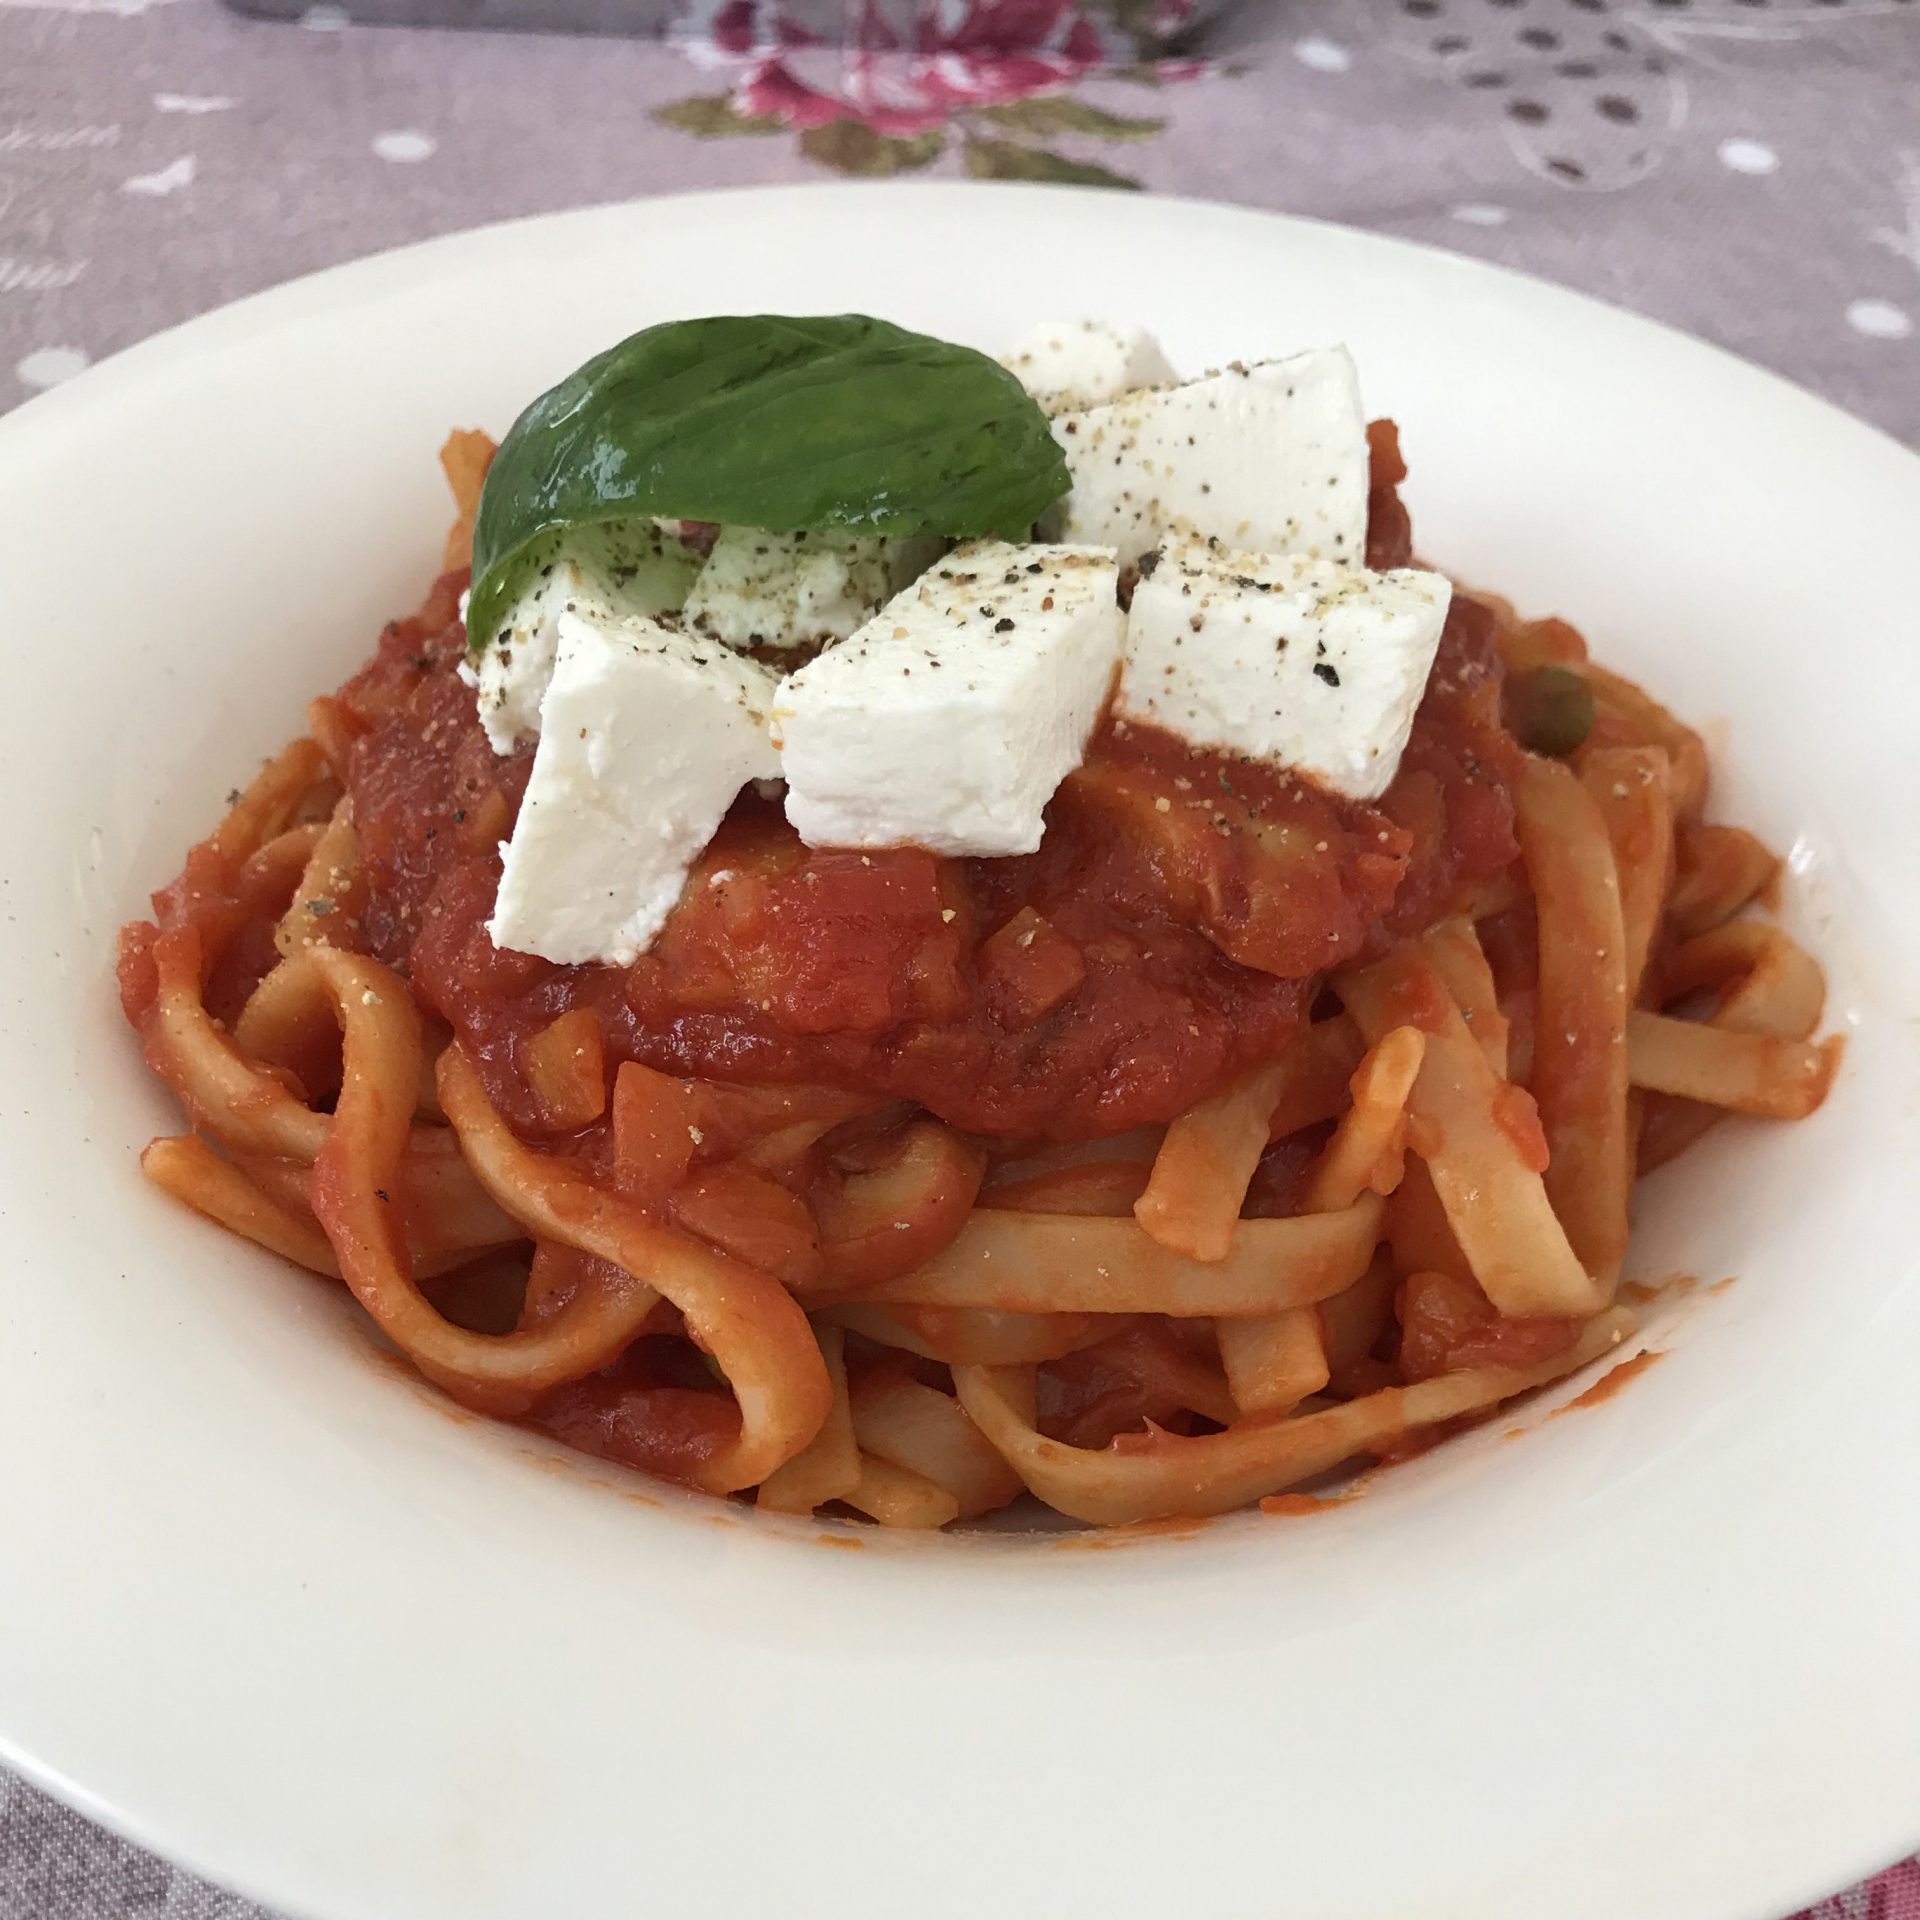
[774,541,1125,854]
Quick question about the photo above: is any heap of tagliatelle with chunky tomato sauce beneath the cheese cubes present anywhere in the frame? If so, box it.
[119,434,1839,1528]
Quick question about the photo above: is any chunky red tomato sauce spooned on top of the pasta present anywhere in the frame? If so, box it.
[334,447,1517,1136]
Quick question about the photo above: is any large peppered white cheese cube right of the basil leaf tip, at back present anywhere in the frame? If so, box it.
[1054,348,1367,566]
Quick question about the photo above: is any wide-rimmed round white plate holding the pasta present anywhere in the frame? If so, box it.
[0,184,1920,1920]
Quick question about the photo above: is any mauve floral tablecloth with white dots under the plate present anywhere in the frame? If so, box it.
[0,0,1920,1920]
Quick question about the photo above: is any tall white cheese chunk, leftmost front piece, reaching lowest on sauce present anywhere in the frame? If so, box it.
[488,611,780,966]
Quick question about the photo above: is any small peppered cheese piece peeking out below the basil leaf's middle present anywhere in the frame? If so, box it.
[685,526,941,647]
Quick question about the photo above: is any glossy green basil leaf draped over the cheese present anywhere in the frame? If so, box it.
[467,313,1068,645]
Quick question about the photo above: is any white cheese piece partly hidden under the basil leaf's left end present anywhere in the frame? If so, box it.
[459,520,701,753]
